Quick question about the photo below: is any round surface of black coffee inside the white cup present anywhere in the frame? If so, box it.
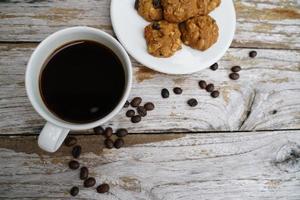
[40,41,125,123]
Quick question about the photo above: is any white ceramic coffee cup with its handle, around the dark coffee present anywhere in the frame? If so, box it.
[25,26,132,152]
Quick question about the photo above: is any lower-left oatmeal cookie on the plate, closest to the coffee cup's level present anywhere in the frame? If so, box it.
[144,21,181,57]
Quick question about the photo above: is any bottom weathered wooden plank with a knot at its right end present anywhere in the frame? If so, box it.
[0,131,300,200]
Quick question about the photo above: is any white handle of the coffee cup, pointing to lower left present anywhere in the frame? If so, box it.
[38,122,70,152]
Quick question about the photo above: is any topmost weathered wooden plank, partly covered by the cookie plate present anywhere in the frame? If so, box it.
[0,0,300,49]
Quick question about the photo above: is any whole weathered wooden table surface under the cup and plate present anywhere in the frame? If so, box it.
[0,0,300,200]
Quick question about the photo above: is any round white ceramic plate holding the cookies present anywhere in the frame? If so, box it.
[110,0,236,74]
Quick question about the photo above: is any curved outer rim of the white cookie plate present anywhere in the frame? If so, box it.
[110,0,236,75]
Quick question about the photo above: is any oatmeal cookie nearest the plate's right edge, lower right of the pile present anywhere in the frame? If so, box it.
[180,15,219,51]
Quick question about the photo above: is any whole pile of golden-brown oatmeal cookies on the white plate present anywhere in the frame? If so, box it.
[135,0,221,57]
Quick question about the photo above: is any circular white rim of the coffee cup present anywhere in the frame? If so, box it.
[25,26,132,130]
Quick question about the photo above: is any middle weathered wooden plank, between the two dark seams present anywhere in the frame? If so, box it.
[0,44,300,134]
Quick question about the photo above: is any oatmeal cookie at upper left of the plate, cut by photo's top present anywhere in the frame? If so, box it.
[135,0,163,22]
